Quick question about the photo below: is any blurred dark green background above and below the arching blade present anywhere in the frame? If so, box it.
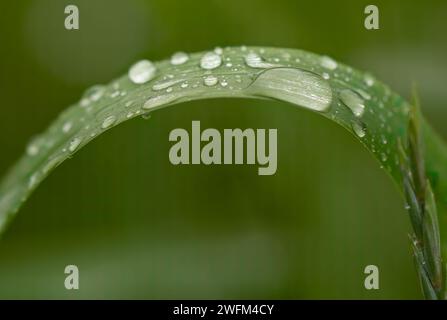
[0,0,447,299]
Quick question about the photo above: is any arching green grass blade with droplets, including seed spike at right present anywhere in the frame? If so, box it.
[0,47,447,298]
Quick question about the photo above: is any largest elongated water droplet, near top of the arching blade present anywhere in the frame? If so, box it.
[247,68,332,111]
